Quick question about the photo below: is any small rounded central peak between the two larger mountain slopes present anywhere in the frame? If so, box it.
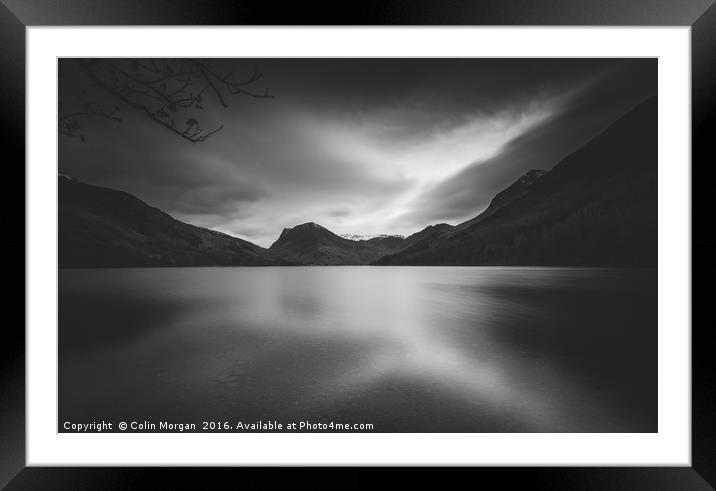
[265,222,405,265]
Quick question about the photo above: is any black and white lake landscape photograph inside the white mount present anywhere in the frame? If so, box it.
[58,58,659,433]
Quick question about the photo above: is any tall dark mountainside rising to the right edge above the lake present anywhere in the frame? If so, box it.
[376,98,658,266]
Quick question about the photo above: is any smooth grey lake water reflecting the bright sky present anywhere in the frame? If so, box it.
[59,266,657,432]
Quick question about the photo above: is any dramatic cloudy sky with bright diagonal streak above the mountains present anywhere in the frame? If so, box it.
[59,59,657,247]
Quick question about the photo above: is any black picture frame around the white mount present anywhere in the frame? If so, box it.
[0,0,716,490]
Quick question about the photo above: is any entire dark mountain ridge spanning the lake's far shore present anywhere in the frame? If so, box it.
[58,98,658,267]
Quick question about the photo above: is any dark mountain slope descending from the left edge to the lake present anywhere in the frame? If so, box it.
[58,175,269,268]
